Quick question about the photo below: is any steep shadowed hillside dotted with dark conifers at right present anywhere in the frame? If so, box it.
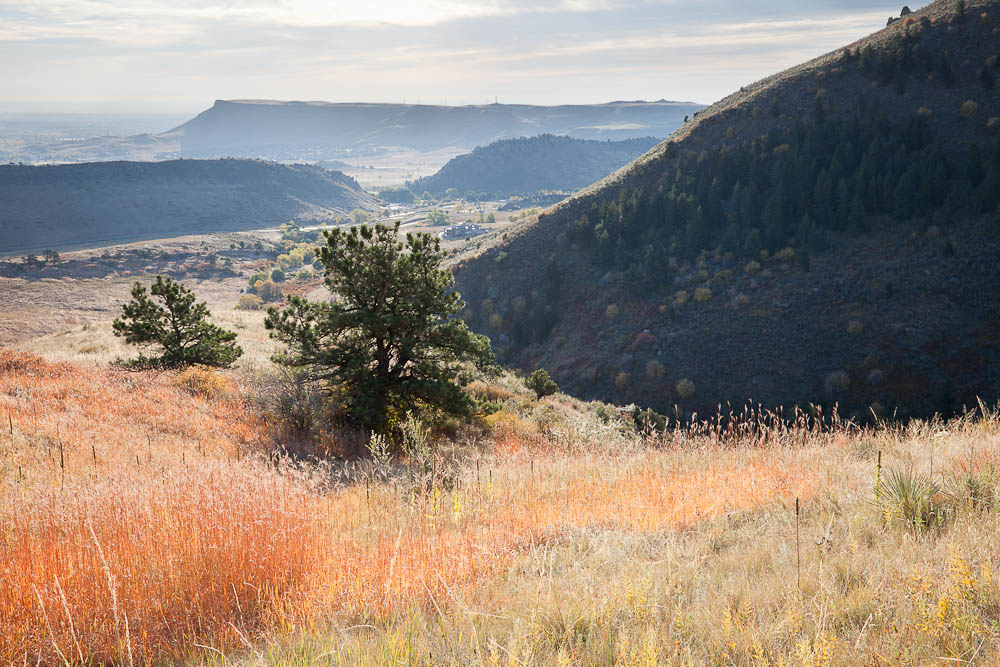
[456,0,1000,422]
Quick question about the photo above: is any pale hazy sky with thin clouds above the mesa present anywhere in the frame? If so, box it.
[0,0,920,112]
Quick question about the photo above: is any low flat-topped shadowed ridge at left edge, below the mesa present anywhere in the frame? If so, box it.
[0,160,375,253]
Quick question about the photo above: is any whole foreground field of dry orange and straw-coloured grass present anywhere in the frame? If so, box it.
[0,336,1000,665]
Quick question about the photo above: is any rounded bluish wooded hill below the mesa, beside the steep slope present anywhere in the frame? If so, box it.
[409,134,658,199]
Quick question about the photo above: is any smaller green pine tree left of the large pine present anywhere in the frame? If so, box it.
[112,276,243,368]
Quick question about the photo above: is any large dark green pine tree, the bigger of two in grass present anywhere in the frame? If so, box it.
[265,222,494,433]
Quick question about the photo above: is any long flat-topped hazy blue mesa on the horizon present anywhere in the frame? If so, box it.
[161,100,702,159]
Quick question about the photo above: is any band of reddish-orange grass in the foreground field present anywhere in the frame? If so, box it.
[0,352,818,664]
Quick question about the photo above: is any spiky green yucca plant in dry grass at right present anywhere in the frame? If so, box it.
[875,466,949,529]
